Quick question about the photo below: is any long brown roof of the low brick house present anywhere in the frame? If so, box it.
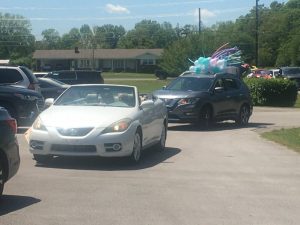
[33,49,163,59]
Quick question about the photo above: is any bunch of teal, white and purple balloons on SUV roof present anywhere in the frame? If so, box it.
[189,43,243,74]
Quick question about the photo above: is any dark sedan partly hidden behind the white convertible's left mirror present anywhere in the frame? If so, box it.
[38,77,70,99]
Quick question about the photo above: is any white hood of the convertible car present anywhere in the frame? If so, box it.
[40,105,136,128]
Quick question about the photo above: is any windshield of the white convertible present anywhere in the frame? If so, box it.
[54,85,136,107]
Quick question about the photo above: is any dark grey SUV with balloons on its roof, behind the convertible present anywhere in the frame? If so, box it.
[153,72,253,127]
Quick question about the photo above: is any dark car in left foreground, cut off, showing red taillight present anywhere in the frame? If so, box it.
[0,107,20,196]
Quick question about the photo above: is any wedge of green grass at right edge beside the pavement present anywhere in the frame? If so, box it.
[261,128,300,153]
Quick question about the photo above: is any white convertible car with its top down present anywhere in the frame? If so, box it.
[27,84,168,163]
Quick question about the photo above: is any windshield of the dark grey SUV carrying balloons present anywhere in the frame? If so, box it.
[166,76,213,91]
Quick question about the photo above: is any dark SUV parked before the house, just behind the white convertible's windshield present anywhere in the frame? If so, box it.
[44,70,104,84]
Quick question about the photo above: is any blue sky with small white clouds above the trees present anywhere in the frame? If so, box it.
[0,0,287,39]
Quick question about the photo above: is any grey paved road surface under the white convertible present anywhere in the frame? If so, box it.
[0,108,300,225]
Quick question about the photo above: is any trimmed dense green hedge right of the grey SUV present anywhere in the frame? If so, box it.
[244,78,298,107]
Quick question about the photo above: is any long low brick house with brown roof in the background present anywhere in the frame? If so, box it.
[33,49,163,72]
